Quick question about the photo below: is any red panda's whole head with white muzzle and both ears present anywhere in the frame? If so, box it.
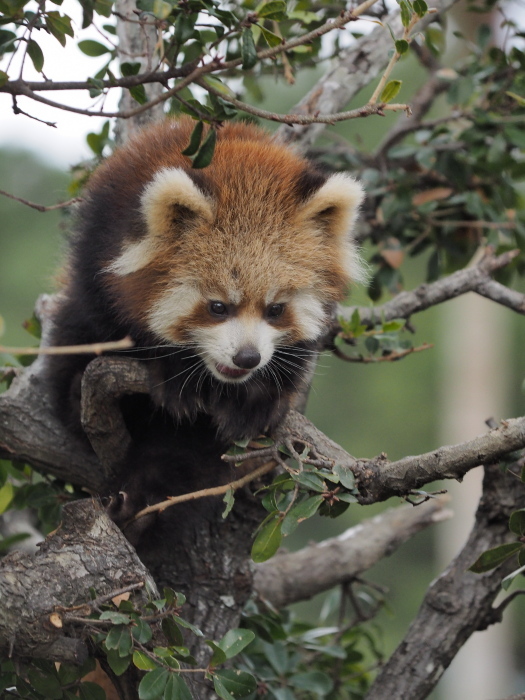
[105,120,363,382]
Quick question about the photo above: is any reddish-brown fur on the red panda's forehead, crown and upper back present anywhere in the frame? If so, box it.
[90,118,354,335]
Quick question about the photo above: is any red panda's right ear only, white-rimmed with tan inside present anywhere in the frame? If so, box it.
[302,173,364,242]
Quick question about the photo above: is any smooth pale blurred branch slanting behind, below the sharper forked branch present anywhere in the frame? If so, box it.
[254,497,452,608]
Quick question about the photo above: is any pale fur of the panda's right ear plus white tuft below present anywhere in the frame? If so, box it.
[303,173,367,282]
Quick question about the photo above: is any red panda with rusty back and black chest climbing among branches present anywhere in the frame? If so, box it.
[50,118,362,528]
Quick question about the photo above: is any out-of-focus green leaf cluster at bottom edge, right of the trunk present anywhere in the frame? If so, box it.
[240,590,383,700]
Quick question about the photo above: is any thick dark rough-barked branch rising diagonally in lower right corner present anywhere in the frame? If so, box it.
[366,466,525,700]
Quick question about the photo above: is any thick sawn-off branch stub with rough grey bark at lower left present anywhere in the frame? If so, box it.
[0,499,156,663]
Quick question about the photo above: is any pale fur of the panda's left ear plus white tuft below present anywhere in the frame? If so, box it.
[106,168,213,276]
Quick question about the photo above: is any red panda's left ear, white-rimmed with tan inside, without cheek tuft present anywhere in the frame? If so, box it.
[141,168,213,238]
